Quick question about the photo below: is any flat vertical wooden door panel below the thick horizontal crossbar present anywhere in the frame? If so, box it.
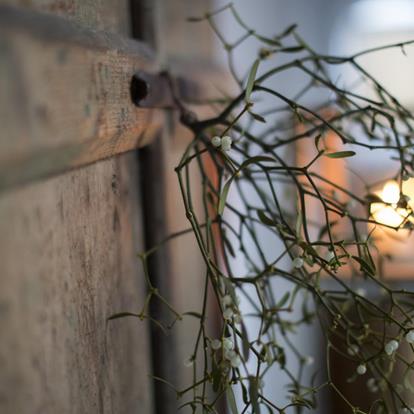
[0,153,152,414]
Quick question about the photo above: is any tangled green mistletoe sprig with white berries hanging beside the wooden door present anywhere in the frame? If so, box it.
[120,4,414,414]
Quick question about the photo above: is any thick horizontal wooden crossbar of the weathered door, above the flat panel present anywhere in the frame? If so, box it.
[0,6,160,190]
